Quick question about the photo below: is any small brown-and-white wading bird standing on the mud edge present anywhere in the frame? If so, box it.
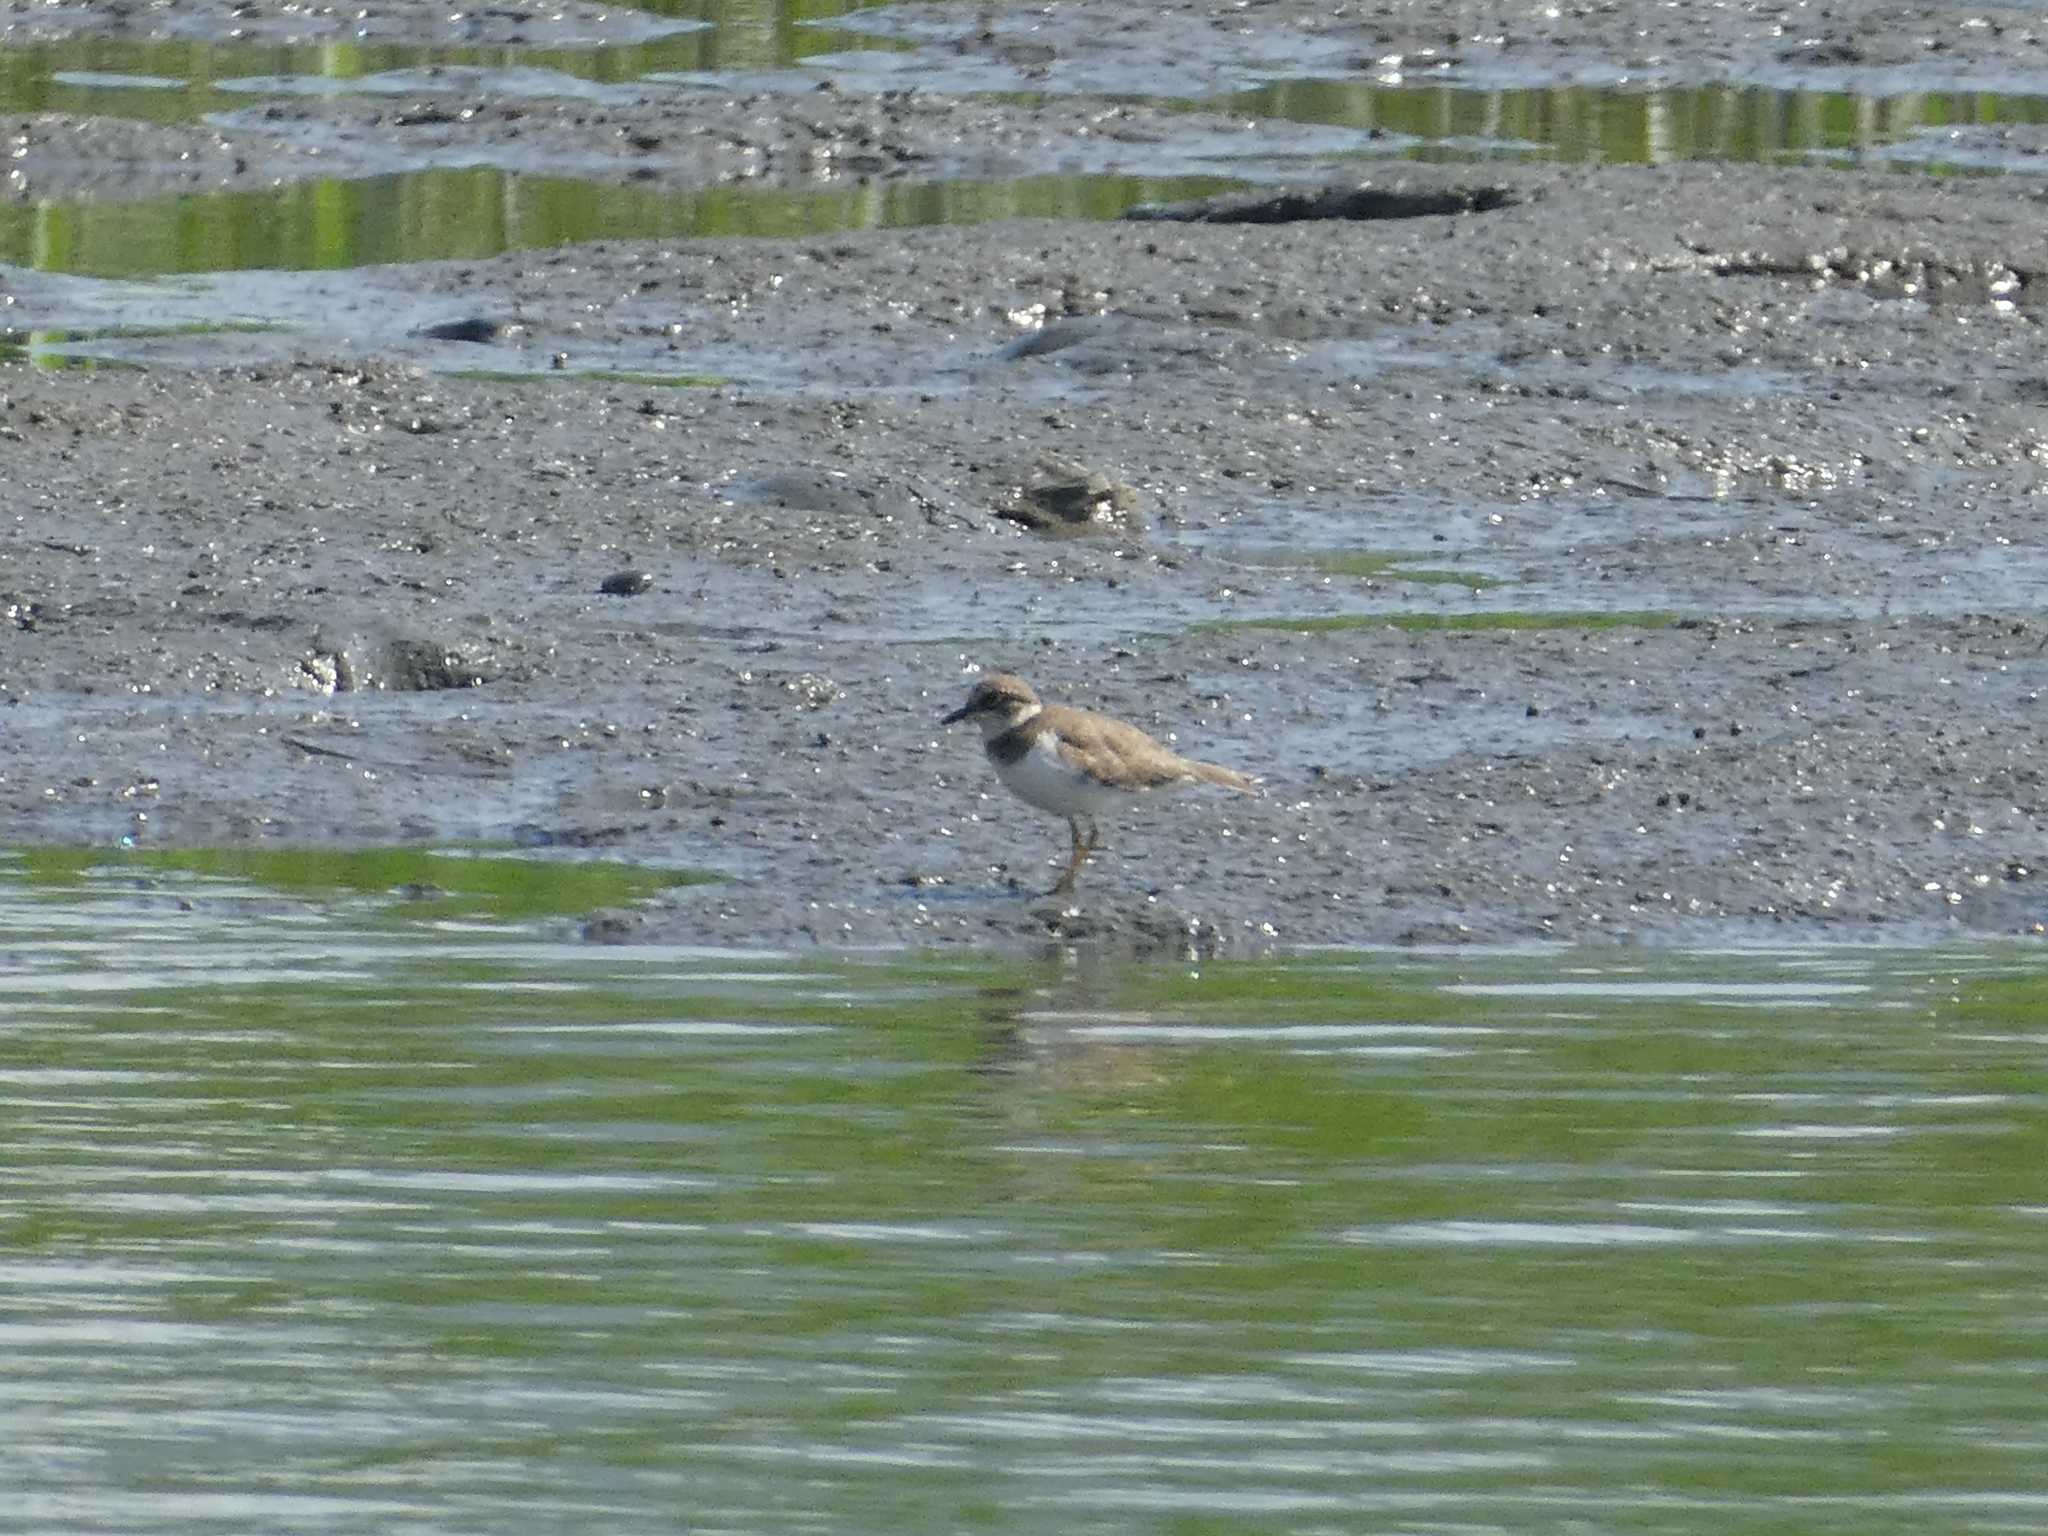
[944,672,1260,895]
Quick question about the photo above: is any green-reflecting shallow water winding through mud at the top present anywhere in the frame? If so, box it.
[0,12,2048,296]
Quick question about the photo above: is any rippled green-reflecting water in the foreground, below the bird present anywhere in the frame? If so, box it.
[0,856,2048,1532]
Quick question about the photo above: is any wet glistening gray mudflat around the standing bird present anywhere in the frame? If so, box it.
[0,4,2048,952]
